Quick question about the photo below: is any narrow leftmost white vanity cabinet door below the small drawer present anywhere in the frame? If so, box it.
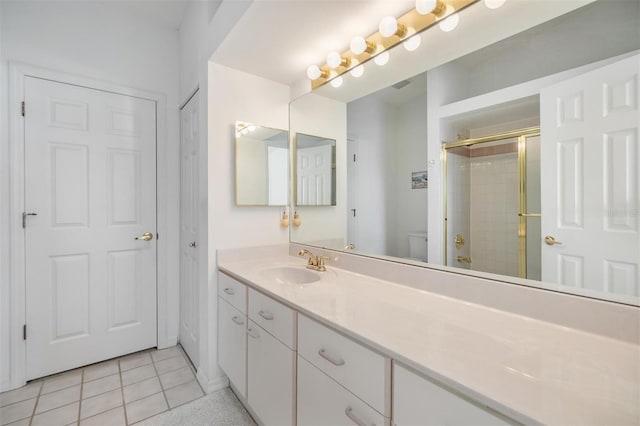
[218,297,247,397]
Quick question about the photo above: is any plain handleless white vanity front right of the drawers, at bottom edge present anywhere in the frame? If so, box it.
[392,361,510,426]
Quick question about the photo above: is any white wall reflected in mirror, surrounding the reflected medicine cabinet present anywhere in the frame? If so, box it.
[289,94,347,249]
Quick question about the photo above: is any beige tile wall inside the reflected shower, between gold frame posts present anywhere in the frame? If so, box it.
[469,151,519,276]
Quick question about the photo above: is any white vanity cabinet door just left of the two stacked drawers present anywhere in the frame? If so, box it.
[247,321,295,425]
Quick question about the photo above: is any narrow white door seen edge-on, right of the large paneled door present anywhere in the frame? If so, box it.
[180,92,200,366]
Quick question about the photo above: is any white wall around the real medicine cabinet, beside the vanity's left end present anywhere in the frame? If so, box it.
[205,63,289,390]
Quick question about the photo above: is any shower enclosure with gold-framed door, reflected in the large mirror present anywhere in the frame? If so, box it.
[442,127,541,280]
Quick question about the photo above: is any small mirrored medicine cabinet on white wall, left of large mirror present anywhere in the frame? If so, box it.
[236,121,289,206]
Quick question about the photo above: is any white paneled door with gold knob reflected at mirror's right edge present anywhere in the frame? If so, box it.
[541,55,640,296]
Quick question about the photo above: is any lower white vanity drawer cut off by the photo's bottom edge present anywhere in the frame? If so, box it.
[297,356,389,426]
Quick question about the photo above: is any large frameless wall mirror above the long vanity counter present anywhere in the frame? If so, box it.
[291,0,640,305]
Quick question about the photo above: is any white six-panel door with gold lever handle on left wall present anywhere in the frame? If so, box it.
[24,77,157,380]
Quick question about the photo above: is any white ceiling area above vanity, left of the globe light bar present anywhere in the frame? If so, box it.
[211,0,414,85]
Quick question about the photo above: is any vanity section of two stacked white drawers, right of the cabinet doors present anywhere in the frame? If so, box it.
[298,315,391,425]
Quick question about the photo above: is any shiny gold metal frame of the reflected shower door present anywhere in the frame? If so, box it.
[442,127,541,278]
